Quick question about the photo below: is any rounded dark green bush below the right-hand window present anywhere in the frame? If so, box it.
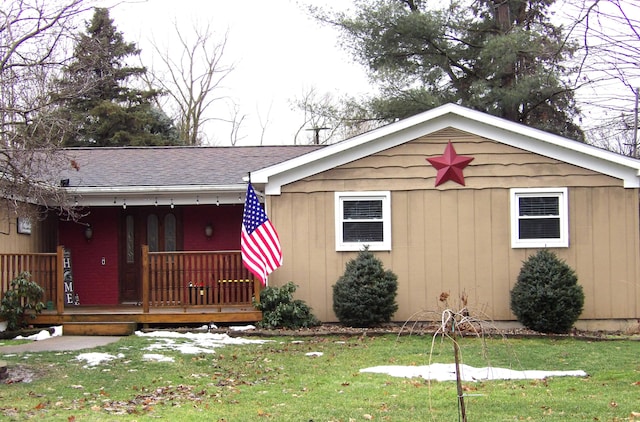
[511,249,584,333]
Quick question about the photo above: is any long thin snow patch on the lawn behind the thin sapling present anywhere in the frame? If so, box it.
[360,363,587,382]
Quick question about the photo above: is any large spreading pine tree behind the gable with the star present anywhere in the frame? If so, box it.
[312,0,584,140]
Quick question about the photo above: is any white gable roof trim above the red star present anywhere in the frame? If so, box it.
[251,104,640,195]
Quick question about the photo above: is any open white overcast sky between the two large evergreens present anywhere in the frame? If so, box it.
[98,0,368,145]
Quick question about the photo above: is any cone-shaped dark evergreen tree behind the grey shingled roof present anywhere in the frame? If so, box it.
[54,8,178,147]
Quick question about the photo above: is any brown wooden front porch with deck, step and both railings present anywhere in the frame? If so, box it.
[0,245,262,334]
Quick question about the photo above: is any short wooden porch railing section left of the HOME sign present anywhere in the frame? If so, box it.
[0,246,63,309]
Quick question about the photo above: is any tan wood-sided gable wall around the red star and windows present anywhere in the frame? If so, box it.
[269,130,640,321]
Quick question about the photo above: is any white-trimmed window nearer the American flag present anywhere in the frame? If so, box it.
[335,191,391,251]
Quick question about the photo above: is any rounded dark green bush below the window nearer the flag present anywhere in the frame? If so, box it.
[333,248,398,327]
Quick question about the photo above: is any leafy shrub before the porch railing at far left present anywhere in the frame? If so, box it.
[0,272,45,331]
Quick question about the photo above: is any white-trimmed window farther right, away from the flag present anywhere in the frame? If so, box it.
[511,188,569,248]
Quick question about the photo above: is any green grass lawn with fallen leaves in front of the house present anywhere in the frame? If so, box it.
[0,335,640,422]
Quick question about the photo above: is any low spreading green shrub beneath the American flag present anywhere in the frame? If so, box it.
[254,282,320,329]
